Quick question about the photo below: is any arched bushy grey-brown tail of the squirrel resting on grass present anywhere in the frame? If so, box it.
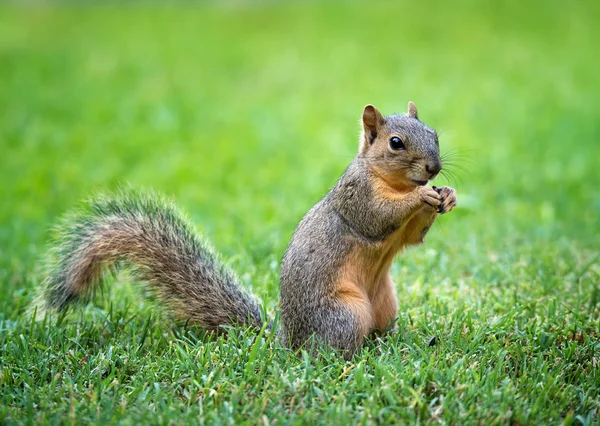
[36,193,263,330]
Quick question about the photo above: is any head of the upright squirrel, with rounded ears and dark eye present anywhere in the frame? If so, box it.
[358,102,442,189]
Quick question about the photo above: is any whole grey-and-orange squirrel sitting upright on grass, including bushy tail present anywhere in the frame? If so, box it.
[41,102,456,356]
